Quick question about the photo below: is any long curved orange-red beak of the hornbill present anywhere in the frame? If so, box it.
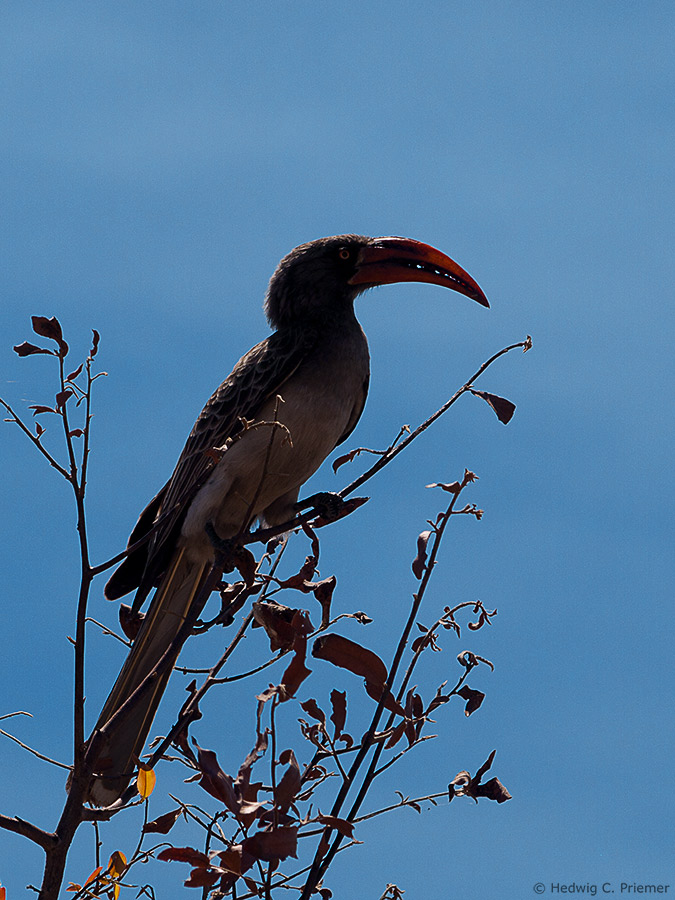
[349,237,490,307]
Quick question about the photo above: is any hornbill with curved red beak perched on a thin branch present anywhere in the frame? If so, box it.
[88,234,489,806]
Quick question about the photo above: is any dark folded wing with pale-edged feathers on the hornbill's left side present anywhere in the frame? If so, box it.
[105,328,317,609]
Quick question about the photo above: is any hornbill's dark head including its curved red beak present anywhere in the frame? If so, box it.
[265,234,490,328]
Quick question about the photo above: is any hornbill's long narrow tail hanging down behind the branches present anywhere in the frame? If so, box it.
[89,550,211,806]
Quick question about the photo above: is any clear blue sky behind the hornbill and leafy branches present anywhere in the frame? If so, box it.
[0,0,675,900]
